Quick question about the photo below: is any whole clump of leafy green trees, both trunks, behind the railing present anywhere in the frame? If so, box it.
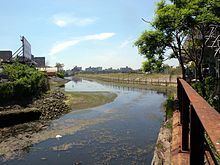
[135,0,220,95]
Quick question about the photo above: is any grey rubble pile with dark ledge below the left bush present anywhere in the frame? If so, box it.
[0,90,71,127]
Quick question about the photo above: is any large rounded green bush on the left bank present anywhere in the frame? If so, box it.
[0,62,49,105]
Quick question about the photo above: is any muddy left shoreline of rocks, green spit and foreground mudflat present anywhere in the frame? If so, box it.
[0,78,117,162]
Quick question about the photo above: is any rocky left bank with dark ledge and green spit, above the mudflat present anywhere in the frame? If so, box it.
[0,77,117,128]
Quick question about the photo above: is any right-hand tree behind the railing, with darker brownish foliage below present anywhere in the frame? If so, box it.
[177,0,220,97]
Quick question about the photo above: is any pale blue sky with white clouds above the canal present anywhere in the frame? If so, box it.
[0,0,176,69]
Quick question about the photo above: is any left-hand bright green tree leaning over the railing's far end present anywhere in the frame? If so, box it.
[135,1,186,79]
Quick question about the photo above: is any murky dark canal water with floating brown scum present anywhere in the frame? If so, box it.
[0,80,166,165]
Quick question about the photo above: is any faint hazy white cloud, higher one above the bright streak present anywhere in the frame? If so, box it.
[52,14,97,27]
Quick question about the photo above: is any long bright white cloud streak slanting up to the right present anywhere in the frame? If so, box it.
[49,33,115,55]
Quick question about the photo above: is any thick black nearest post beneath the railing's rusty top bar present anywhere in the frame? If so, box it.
[190,105,205,164]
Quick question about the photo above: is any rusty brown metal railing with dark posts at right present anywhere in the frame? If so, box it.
[177,79,220,164]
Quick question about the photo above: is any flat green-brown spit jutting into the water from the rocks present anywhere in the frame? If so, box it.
[64,92,117,110]
